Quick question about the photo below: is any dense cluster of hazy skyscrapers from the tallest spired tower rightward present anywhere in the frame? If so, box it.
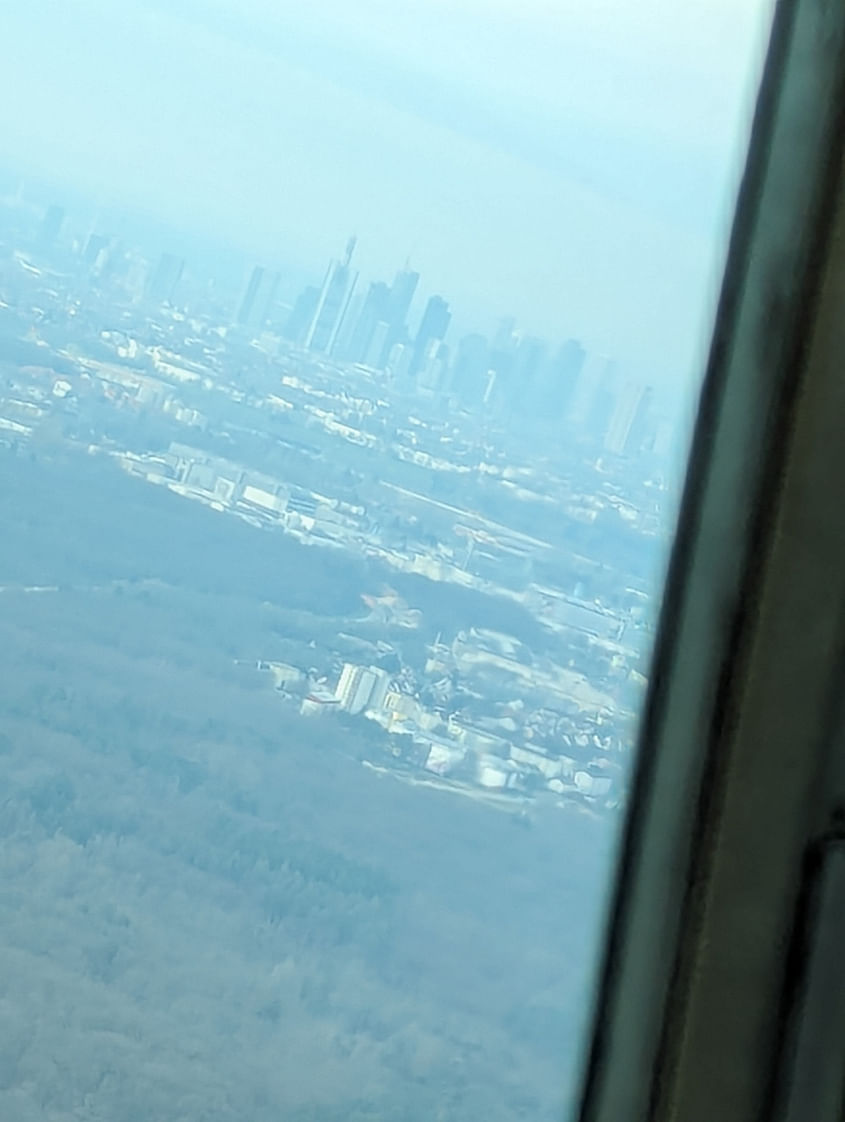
[270,238,656,454]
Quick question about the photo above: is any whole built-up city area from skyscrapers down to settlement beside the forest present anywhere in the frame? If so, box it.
[0,200,672,810]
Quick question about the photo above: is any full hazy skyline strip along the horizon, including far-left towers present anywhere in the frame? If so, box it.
[1,182,664,456]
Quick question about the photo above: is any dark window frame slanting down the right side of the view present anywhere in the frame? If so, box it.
[579,0,845,1122]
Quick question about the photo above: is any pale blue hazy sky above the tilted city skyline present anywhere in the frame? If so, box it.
[0,0,769,378]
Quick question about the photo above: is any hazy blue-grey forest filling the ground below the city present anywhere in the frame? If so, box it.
[0,448,614,1122]
